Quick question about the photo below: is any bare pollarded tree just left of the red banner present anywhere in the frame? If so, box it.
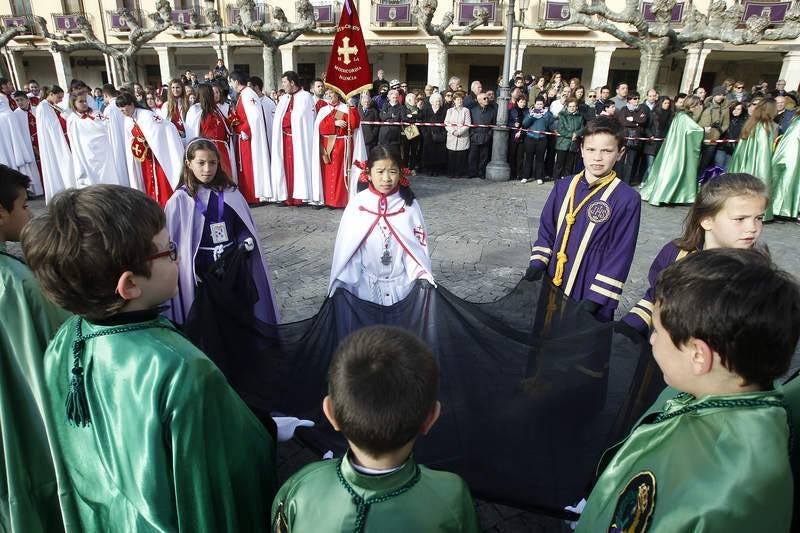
[176,0,336,91]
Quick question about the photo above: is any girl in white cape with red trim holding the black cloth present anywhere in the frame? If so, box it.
[328,146,434,305]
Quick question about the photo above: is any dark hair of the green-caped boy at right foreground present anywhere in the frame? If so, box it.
[655,249,800,388]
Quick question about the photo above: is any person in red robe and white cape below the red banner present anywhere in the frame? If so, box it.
[312,89,363,207]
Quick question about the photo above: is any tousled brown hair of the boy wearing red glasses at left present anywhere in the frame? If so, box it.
[22,185,166,320]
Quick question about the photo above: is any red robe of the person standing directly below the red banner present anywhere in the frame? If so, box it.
[319,107,361,207]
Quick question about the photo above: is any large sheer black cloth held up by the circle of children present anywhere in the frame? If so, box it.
[184,247,665,516]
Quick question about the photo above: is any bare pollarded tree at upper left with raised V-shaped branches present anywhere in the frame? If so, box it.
[36,0,172,82]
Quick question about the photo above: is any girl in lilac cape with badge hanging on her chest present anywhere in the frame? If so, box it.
[165,138,279,324]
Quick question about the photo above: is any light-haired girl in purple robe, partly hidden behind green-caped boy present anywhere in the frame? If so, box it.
[616,174,769,337]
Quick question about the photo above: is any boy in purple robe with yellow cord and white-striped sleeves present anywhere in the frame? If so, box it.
[525,116,641,321]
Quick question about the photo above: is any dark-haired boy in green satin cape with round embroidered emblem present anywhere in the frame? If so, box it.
[577,249,800,533]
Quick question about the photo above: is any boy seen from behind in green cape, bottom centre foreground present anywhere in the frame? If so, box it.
[272,326,479,533]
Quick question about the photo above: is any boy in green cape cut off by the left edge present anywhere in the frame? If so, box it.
[0,165,68,533]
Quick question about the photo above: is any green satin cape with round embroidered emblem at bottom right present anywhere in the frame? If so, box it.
[576,389,793,533]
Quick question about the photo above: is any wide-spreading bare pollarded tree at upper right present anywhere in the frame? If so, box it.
[516,0,800,93]
